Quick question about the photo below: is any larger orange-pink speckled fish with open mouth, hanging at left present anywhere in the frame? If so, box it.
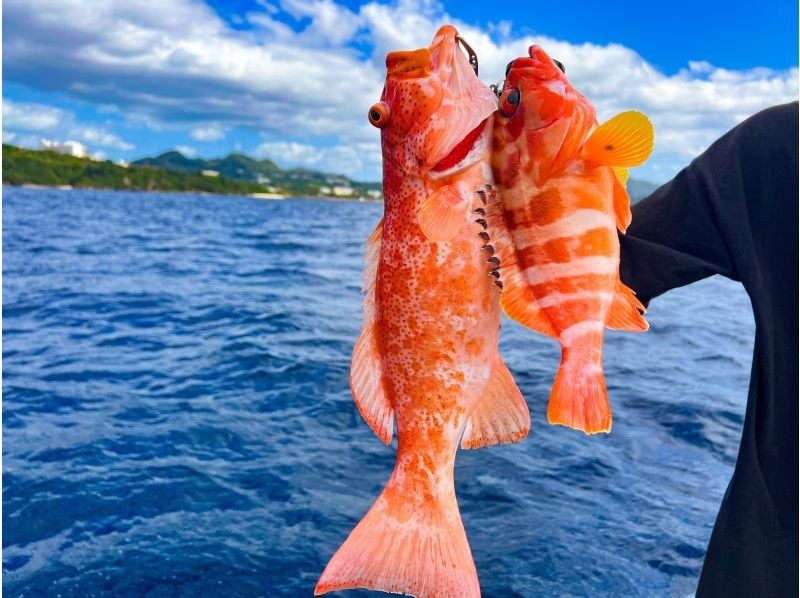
[315,26,530,598]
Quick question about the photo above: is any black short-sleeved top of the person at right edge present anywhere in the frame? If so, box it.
[620,102,798,598]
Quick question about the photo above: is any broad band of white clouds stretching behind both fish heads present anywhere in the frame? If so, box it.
[3,0,798,180]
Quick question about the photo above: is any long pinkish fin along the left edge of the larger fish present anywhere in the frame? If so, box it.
[350,219,394,444]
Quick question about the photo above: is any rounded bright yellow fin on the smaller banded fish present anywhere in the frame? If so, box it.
[581,110,653,168]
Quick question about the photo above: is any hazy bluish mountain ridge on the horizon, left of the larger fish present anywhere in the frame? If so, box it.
[131,150,381,195]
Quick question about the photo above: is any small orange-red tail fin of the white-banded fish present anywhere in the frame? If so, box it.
[547,347,611,434]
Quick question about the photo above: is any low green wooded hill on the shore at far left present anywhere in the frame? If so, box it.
[3,143,267,194]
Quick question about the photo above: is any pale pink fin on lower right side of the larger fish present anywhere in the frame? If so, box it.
[461,359,531,449]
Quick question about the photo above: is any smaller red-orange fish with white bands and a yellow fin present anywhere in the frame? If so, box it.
[492,46,653,434]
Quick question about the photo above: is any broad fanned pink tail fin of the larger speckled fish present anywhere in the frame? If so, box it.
[314,470,480,598]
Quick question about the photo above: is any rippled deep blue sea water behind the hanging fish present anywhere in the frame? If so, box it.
[3,187,753,598]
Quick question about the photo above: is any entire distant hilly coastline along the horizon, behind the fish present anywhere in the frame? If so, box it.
[3,143,658,203]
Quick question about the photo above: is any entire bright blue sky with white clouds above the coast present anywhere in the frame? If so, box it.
[2,0,798,182]
